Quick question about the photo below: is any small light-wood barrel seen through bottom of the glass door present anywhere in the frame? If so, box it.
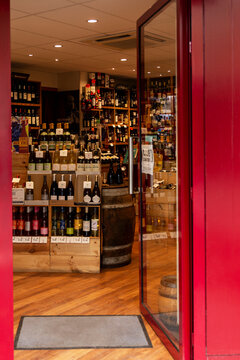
[158,275,177,313]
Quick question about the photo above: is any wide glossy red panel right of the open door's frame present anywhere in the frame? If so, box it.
[204,0,240,359]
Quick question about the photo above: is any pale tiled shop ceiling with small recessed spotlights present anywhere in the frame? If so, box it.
[11,0,175,77]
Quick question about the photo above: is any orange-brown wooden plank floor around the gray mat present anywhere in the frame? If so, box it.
[14,241,172,360]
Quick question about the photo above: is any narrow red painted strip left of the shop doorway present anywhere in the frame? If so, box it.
[0,0,13,360]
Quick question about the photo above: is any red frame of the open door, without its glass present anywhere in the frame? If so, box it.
[137,0,192,359]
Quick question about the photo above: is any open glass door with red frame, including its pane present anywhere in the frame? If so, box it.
[138,0,190,359]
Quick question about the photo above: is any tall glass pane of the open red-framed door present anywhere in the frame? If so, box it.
[141,1,179,348]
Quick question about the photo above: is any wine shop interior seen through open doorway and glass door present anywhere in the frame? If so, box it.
[11,0,176,360]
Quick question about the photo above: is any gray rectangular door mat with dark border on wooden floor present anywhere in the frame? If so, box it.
[14,315,152,350]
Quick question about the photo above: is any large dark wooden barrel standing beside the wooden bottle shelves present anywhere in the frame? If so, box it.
[101,186,135,268]
